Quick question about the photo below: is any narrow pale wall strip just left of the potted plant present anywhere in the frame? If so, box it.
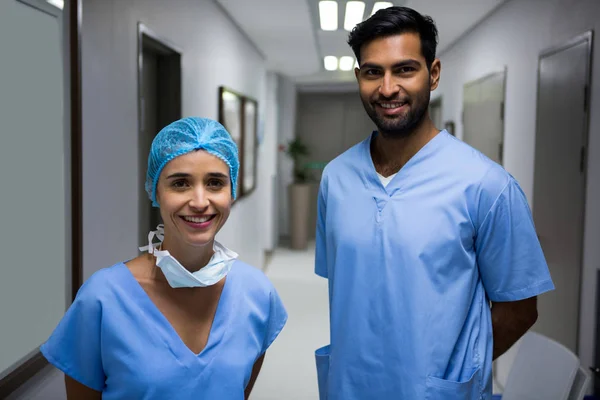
[277,75,296,238]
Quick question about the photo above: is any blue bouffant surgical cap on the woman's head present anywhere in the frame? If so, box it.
[146,117,240,207]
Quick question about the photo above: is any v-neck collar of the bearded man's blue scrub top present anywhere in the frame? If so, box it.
[362,130,448,198]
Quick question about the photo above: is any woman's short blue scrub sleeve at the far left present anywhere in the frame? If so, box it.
[40,277,106,392]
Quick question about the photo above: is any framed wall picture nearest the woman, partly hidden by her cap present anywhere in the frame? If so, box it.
[219,86,244,199]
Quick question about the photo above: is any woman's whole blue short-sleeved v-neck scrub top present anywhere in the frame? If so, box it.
[41,261,287,400]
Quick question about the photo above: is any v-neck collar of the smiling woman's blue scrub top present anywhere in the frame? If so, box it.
[121,263,235,365]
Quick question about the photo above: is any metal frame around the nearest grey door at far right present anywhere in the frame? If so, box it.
[533,29,594,354]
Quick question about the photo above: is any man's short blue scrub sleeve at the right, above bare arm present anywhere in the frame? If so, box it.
[475,177,554,302]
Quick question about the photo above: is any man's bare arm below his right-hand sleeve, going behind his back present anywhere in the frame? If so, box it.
[492,296,538,360]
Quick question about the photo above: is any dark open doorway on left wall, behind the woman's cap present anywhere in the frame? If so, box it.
[138,23,181,246]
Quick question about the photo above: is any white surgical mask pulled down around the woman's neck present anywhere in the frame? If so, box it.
[140,225,238,288]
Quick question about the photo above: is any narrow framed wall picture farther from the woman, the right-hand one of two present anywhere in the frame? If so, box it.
[240,97,258,196]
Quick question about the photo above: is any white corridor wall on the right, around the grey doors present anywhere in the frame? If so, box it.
[434,0,600,388]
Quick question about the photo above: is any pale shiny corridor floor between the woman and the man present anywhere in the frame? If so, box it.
[250,245,329,400]
